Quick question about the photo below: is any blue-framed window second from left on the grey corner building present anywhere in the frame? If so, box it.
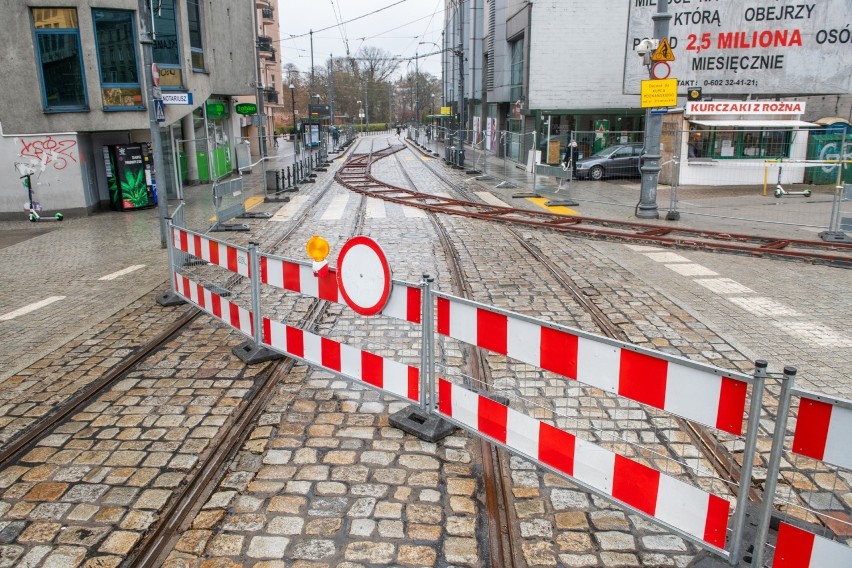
[92,9,145,110]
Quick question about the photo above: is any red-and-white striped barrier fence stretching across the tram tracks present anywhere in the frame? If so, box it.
[158,225,852,566]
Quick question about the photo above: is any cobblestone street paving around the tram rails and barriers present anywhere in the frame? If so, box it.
[0,132,852,568]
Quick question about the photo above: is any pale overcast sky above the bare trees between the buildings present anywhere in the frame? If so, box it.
[277,0,444,77]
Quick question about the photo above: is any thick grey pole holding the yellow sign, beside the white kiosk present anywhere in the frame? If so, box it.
[636,0,672,219]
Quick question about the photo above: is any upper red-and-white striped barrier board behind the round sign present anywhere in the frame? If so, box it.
[260,255,421,323]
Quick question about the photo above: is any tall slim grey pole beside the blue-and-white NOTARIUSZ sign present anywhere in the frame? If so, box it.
[139,0,169,248]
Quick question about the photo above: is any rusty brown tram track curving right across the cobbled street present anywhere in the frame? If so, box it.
[335,141,852,268]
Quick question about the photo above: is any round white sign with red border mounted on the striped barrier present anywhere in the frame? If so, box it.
[337,235,391,316]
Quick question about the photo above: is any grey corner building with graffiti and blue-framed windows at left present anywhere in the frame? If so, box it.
[0,0,256,218]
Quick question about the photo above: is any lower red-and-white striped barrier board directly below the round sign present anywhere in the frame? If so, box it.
[263,318,420,402]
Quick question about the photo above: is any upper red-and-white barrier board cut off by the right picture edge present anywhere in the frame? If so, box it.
[793,395,852,470]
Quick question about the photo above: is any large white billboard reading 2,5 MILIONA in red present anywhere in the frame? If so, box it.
[624,0,852,95]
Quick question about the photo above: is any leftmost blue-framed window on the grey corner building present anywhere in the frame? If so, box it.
[32,8,89,112]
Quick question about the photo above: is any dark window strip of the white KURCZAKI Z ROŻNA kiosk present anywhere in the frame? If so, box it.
[688,128,791,160]
